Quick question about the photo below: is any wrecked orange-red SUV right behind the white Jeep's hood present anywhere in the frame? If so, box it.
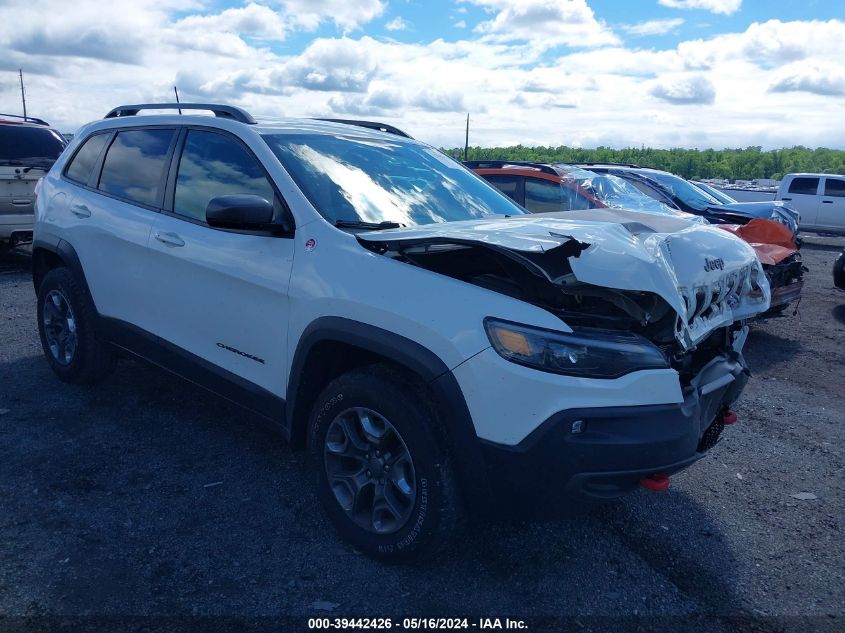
[464,160,806,316]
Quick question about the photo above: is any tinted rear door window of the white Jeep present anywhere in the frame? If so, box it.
[99,130,173,205]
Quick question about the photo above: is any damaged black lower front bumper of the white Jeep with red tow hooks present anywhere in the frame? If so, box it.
[482,329,749,510]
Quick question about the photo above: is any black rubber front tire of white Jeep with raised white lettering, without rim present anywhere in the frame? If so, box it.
[308,364,461,561]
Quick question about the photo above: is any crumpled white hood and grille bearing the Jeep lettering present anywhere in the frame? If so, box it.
[359,210,770,353]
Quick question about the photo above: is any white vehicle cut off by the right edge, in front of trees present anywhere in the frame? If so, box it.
[775,174,845,234]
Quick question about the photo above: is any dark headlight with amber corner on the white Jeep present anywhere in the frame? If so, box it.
[484,318,669,378]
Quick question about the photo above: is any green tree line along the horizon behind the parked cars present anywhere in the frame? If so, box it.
[452,145,845,180]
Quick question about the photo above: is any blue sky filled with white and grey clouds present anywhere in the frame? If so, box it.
[0,0,845,149]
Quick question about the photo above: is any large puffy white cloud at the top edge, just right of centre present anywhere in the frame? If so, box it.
[466,0,619,47]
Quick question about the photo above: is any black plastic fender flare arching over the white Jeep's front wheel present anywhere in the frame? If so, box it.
[286,317,492,512]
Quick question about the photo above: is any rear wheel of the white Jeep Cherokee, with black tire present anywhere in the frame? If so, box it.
[38,268,115,384]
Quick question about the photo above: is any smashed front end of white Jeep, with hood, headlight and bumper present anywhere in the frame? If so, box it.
[358,209,770,498]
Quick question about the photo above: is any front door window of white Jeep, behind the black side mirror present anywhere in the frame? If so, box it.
[173,130,274,221]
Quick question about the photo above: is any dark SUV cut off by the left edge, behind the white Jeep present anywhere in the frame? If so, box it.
[0,114,67,251]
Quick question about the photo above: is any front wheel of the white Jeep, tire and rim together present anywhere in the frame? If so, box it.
[309,365,459,560]
